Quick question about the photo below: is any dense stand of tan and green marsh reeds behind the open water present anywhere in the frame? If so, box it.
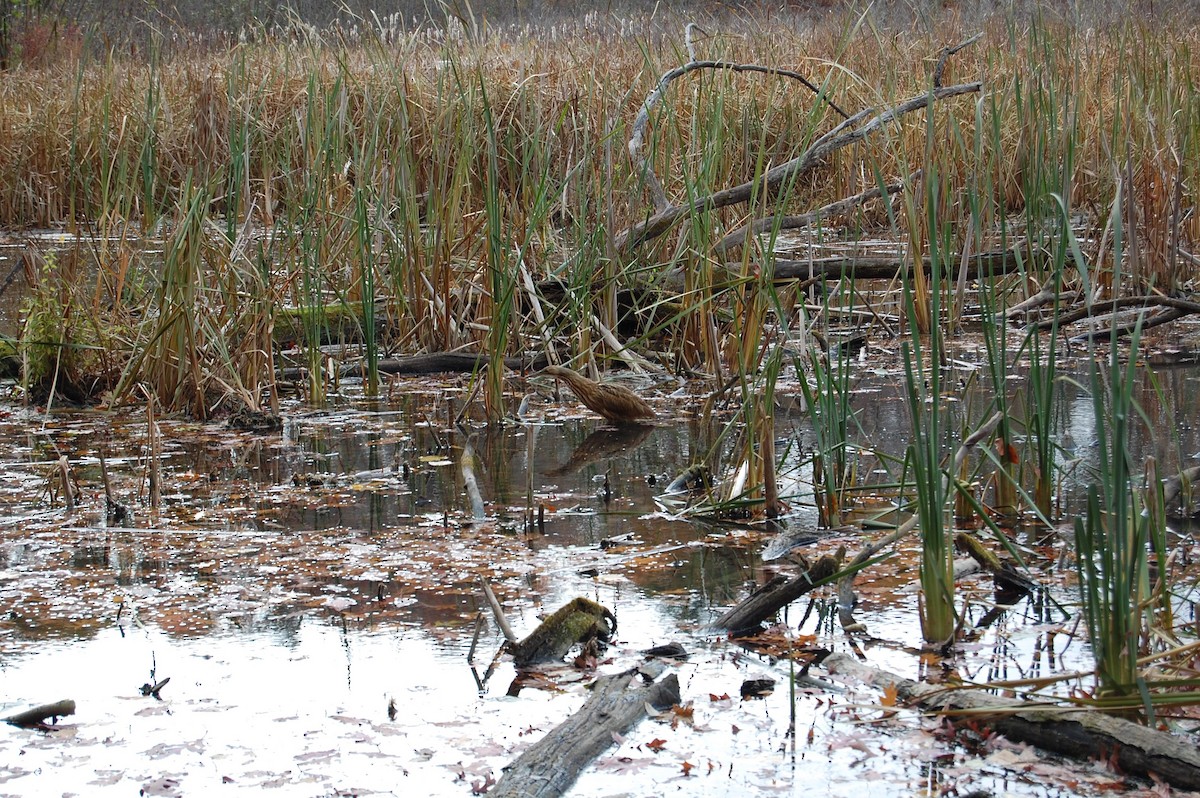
[0,8,1200,410]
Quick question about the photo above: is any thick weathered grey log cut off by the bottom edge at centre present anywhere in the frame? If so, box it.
[488,662,679,798]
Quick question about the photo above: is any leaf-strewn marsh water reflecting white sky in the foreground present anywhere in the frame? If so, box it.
[0,343,1200,796]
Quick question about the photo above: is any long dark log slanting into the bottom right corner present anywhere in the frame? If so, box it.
[822,654,1200,790]
